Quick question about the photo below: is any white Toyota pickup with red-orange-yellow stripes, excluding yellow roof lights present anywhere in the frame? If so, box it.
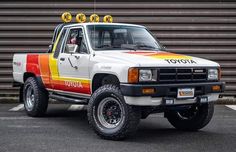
[13,22,225,140]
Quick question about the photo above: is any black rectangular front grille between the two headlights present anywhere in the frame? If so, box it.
[158,68,207,83]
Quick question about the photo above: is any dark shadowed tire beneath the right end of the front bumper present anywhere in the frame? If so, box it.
[165,102,214,131]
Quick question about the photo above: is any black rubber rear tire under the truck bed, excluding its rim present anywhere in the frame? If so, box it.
[23,77,48,117]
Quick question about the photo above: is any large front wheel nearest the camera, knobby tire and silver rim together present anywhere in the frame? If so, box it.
[88,84,141,140]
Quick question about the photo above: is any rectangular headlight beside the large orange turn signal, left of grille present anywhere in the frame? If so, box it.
[139,69,157,82]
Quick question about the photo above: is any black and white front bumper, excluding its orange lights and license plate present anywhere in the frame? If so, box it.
[120,82,225,106]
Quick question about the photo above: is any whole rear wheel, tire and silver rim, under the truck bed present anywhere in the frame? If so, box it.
[23,77,48,117]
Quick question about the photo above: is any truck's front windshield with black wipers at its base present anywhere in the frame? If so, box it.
[87,25,161,51]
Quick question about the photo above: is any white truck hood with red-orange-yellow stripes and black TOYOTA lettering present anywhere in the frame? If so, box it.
[96,50,219,67]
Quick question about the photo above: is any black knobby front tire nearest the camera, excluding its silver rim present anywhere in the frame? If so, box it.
[88,84,141,140]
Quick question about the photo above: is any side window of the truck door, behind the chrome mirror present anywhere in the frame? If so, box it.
[64,28,87,53]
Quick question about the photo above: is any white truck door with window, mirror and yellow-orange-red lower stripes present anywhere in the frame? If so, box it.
[55,27,90,94]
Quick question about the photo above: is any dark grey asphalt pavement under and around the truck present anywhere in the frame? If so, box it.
[0,104,236,152]
